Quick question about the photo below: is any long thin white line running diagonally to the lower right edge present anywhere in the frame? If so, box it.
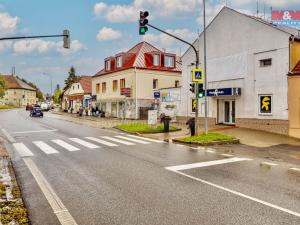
[169,170,300,217]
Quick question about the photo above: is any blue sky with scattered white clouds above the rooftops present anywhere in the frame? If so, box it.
[0,0,300,93]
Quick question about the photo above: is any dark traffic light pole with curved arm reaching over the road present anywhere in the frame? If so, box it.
[147,23,199,135]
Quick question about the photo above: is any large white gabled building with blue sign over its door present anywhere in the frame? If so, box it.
[179,7,299,134]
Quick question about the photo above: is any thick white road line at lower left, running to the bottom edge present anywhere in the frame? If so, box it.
[23,158,77,225]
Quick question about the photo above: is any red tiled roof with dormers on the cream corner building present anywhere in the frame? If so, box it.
[94,41,181,77]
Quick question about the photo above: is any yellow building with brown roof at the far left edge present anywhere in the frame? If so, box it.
[0,75,37,107]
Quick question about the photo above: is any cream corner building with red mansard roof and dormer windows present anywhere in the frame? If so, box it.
[92,42,181,119]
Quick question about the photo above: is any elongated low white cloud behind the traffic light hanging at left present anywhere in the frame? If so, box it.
[13,39,86,56]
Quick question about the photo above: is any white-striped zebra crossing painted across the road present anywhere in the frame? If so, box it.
[13,135,163,157]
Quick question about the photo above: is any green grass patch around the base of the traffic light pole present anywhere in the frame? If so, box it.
[176,133,237,143]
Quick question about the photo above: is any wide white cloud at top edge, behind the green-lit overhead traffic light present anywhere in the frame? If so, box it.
[94,0,199,23]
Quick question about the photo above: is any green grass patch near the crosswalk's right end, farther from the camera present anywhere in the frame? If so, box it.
[116,123,180,133]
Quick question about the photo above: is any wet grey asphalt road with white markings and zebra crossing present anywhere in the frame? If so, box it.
[0,110,300,225]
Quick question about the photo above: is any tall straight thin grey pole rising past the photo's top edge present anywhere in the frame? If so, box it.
[203,0,208,134]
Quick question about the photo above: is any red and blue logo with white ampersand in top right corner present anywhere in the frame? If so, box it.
[272,10,300,28]
